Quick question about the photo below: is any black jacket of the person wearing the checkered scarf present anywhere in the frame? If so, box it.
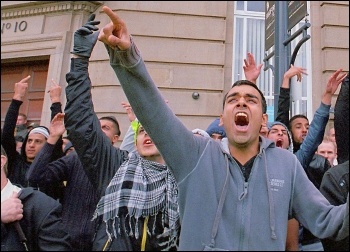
[64,59,131,251]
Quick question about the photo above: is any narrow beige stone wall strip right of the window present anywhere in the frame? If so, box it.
[310,1,349,119]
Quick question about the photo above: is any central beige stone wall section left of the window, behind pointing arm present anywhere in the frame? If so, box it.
[91,1,232,139]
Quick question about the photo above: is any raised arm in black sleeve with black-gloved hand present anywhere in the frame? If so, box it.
[65,15,127,195]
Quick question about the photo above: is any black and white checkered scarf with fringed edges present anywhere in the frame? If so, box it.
[93,151,180,244]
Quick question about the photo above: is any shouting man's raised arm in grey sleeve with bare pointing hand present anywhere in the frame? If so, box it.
[99,6,204,180]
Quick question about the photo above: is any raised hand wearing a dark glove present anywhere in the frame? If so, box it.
[72,14,100,58]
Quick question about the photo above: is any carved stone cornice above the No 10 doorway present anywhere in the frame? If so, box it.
[1,1,103,20]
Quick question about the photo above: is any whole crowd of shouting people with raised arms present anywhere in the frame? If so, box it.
[1,6,349,251]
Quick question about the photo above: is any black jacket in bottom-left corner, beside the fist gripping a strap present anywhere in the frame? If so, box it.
[1,187,72,251]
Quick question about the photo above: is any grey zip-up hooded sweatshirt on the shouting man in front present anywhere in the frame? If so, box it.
[102,37,349,251]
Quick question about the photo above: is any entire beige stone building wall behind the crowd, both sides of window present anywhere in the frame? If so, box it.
[1,1,349,145]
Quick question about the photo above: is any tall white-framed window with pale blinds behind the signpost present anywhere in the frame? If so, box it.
[232,1,312,121]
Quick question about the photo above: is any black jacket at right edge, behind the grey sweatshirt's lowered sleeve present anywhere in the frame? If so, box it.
[320,160,349,251]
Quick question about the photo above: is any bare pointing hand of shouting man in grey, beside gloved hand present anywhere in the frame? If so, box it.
[98,6,131,50]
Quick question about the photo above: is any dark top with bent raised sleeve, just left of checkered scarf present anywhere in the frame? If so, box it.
[27,143,99,251]
